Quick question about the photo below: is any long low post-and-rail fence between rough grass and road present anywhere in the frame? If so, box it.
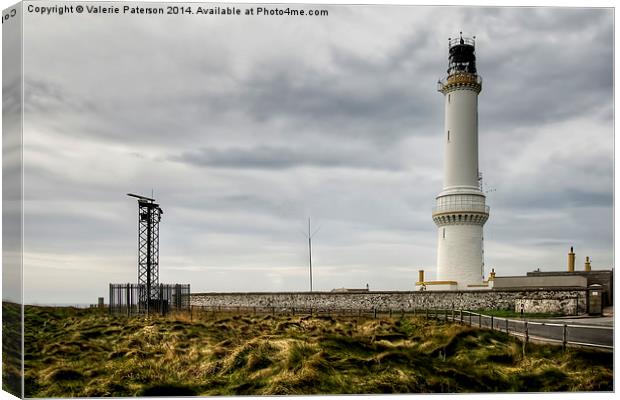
[190,306,614,350]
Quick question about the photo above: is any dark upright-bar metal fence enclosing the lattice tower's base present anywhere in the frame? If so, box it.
[109,283,190,315]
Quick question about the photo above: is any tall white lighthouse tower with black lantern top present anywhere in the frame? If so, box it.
[425,36,489,290]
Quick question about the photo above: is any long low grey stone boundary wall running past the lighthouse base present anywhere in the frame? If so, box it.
[190,288,587,315]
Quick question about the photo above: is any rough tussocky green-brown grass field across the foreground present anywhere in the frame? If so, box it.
[25,307,613,397]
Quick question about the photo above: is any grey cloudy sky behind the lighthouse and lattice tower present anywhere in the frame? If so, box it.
[6,5,614,303]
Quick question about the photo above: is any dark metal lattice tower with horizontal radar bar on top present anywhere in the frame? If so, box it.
[127,193,164,312]
